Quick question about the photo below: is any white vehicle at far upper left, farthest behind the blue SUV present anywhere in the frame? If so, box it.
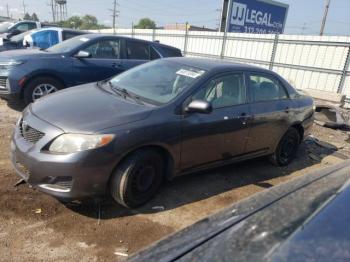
[0,21,55,39]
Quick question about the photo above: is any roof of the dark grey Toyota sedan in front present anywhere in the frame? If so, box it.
[164,57,273,73]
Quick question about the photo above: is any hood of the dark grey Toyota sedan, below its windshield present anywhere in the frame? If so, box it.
[30,83,153,133]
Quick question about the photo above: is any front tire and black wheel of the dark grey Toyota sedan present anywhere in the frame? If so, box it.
[110,150,164,208]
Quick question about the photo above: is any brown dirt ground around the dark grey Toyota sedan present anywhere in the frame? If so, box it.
[0,101,350,261]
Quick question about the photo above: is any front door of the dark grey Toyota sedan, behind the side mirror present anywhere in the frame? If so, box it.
[181,73,250,169]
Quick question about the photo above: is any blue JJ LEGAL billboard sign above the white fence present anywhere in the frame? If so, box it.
[226,0,289,34]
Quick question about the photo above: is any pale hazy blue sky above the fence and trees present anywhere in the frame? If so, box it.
[0,0,350,35]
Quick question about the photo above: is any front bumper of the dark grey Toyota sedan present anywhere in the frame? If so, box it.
[11,109,115,200]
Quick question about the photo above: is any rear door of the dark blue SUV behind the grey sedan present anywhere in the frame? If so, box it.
[123,39,151,70]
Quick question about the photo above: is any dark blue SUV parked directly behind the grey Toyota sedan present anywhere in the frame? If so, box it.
[0,34,181,104]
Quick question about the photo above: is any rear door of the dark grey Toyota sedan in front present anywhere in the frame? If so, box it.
[247,72,294,152]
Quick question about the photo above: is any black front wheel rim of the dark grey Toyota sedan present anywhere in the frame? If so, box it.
[133,164,156,193]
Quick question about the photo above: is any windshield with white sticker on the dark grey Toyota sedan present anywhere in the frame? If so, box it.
[110,60,205,105]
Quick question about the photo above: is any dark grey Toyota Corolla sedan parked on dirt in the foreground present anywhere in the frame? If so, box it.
[11,58,314,208]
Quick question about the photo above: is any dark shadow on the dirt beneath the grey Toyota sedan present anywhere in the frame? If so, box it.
[66,140,344,219]
